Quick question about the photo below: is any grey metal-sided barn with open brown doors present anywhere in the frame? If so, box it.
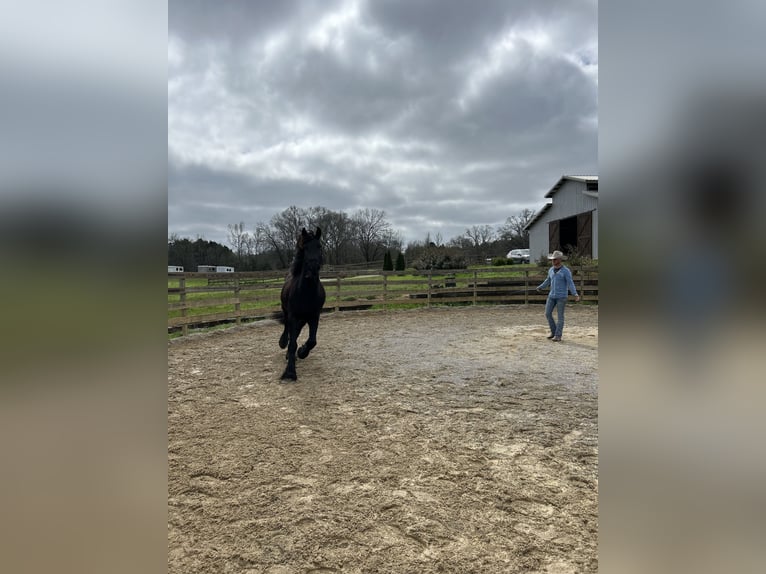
[524,175,598,261]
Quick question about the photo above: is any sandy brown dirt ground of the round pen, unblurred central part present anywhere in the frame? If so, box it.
[168,304,598,574]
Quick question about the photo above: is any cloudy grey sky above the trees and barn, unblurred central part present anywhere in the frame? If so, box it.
[168,0,598,243]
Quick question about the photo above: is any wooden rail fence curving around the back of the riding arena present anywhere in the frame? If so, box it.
[168,266,598,335]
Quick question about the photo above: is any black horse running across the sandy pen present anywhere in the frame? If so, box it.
[279,227,325,381]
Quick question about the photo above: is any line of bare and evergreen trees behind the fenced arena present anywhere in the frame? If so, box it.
[168,206,534,271]
